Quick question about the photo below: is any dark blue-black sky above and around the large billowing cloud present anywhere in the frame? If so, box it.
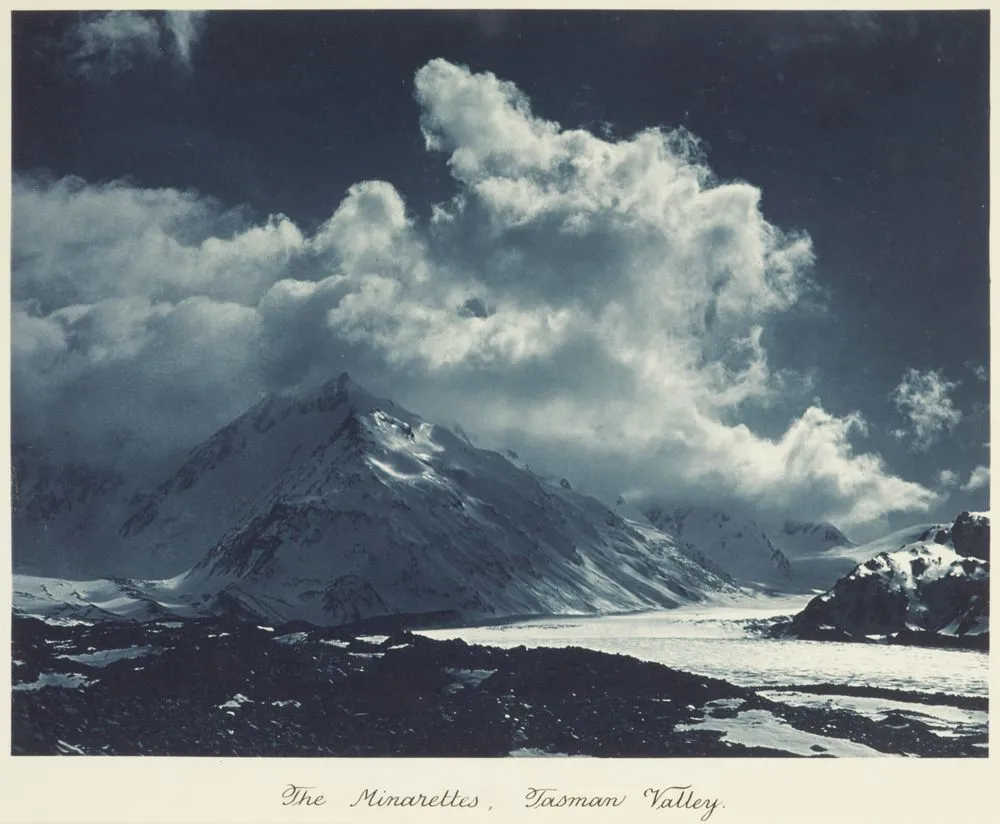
[13,12,989,540]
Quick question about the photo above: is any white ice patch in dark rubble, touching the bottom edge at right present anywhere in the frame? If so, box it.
[674,699,886,758]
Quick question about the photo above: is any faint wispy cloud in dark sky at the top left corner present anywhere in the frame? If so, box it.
[59,11,206,81]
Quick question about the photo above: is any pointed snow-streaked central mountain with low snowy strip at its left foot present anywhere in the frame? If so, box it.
[15,375,731,624]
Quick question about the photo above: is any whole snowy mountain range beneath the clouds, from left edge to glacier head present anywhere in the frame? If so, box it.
[13,374,972,624]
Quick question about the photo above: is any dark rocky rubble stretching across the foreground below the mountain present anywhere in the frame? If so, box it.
[12,615,987,757]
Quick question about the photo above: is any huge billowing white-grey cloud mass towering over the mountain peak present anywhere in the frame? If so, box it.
[13,60,936,526]
